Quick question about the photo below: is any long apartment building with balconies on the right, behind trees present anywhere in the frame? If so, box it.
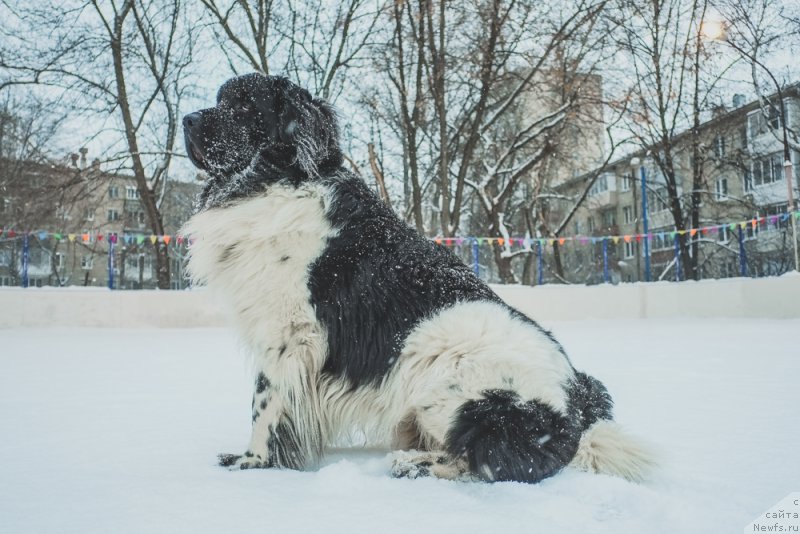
[553,84,800,283]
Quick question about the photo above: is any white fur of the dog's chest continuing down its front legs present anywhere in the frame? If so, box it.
[184,185,334,464]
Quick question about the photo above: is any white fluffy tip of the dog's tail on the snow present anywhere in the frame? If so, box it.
[570,421,656,482]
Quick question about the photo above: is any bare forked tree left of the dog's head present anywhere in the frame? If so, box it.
[0,0,195,289]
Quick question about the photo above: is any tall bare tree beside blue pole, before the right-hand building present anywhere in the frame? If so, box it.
[617,0,736,278]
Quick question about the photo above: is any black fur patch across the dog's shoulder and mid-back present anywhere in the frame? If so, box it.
[309,174,501,387]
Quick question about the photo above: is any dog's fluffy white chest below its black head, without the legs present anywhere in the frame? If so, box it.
[185,186,333,367]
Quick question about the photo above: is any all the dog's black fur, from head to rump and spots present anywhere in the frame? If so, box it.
[184,74,612,482]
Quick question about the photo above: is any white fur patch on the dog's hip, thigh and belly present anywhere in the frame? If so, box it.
[314,302,572,449]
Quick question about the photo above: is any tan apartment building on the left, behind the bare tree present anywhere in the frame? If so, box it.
[0,150,199,289]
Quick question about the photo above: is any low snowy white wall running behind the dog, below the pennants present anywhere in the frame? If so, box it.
[0,274,800,328]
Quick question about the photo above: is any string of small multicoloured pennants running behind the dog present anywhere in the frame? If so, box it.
[0,211,800,248]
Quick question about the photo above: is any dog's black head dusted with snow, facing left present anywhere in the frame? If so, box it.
[183,73,342,209]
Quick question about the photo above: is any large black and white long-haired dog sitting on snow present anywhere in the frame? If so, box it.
[183,74,652,482]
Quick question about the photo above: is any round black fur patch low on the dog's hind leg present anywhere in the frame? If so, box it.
[445,390,583,482]
